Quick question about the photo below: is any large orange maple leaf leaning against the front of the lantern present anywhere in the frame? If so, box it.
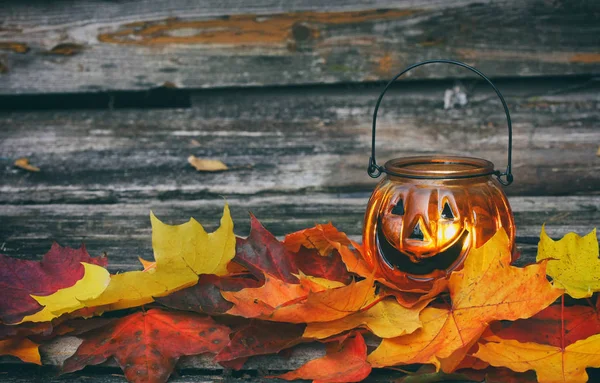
[368,229,562,372]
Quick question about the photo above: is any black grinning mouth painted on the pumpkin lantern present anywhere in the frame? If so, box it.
[377,225,469,275]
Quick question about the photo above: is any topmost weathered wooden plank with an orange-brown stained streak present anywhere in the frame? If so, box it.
[0,0,600,94]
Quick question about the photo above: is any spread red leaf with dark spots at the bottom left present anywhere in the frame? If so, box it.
[62,309,229,383]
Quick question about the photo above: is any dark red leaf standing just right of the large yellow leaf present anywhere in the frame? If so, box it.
[233,214,298,283]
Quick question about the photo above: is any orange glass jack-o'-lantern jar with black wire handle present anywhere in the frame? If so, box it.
[363,60,515,290]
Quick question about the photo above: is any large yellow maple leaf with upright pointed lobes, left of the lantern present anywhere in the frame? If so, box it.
[84,204,235,310]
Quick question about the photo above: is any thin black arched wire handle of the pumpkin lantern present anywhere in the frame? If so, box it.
[367,59,514,186]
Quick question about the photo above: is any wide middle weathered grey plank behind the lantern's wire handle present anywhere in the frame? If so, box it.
[0,80,600,204]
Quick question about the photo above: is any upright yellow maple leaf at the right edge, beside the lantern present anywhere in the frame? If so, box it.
[536,226,600,299]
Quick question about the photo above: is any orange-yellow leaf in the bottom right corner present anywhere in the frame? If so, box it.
[475,334,600,383]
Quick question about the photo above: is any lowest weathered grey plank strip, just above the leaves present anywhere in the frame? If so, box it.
[0,193,600,272]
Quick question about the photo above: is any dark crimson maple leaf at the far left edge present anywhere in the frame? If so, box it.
[0,242,107,323]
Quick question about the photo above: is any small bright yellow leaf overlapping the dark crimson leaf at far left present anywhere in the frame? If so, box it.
[19,262,110,323]
